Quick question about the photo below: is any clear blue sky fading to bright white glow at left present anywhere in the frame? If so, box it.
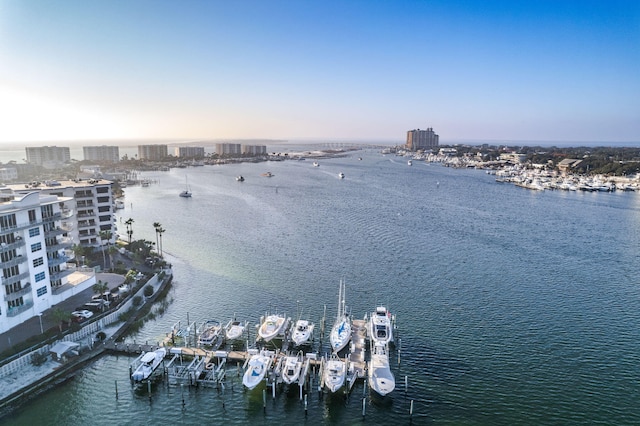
[0,0,640,147]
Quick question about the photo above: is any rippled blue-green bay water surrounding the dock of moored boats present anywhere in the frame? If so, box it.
[0,151,640,425]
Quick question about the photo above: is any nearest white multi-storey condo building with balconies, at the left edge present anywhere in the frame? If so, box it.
[0,186,95,333]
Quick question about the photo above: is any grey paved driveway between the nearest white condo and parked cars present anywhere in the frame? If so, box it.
[0,273,124,353]
